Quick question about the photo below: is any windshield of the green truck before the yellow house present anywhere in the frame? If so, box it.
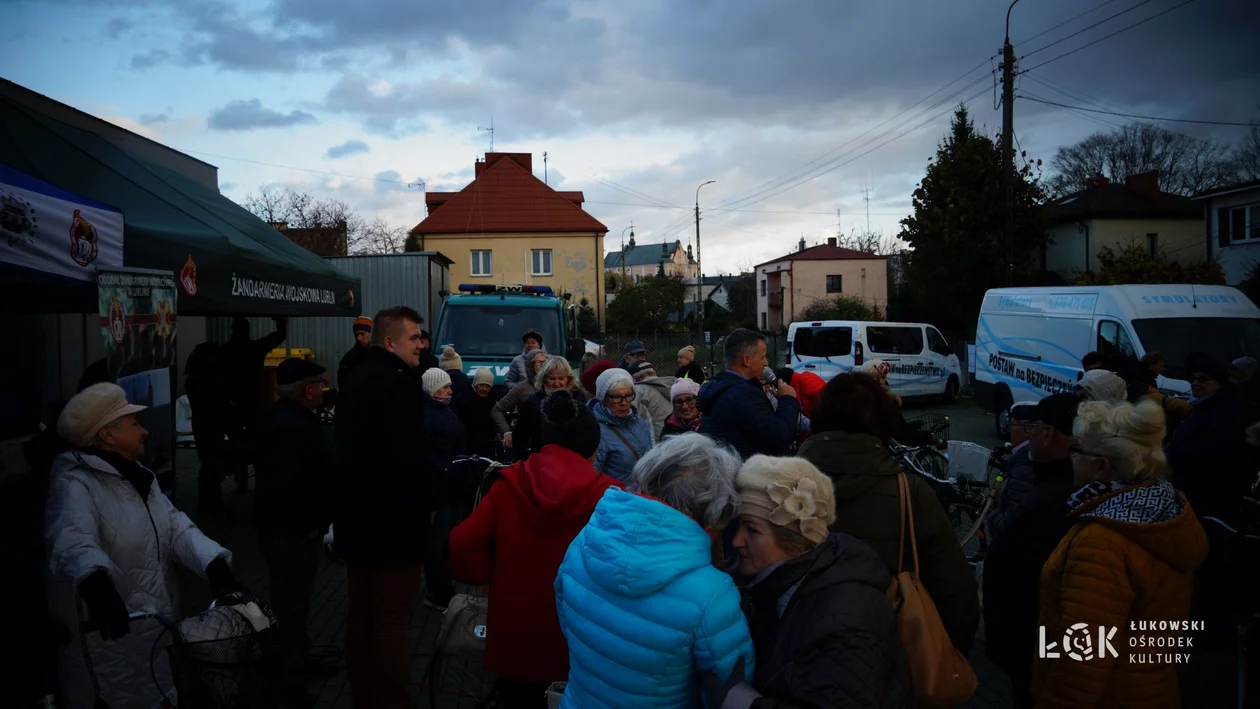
[433,305,561,358]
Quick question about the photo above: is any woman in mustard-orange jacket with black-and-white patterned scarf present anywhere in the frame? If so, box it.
[1033,402,1207,708]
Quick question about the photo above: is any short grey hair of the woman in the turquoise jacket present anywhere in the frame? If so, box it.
[630,433,740,529]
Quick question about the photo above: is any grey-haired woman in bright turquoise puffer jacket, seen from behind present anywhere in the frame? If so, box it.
[556,433,755,709]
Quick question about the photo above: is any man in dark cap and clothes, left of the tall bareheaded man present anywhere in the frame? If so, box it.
[253,358,336,706]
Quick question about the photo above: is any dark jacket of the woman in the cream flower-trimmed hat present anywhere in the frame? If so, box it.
[743,534,915,709]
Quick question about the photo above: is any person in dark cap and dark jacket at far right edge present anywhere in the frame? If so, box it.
[1164,355,1255,524]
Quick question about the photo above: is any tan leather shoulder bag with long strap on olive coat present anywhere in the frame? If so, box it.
[888,472,979,709]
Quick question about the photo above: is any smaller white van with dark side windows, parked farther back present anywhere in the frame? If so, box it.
[788,320,961,400]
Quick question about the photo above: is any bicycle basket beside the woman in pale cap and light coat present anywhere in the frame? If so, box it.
[168,596,278,709]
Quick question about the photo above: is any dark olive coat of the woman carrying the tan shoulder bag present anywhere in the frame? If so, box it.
[798,431,980,655]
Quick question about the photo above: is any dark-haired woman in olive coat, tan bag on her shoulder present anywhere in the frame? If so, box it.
[798,374,980,655]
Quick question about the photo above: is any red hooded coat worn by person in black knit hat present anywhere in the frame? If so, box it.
[451,445,621,684]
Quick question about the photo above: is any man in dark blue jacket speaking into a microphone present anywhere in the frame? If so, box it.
[696,327,800,460]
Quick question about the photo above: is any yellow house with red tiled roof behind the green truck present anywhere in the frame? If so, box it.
[412,152,609,327]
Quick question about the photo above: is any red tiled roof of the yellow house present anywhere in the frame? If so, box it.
[412,154,609,235]
